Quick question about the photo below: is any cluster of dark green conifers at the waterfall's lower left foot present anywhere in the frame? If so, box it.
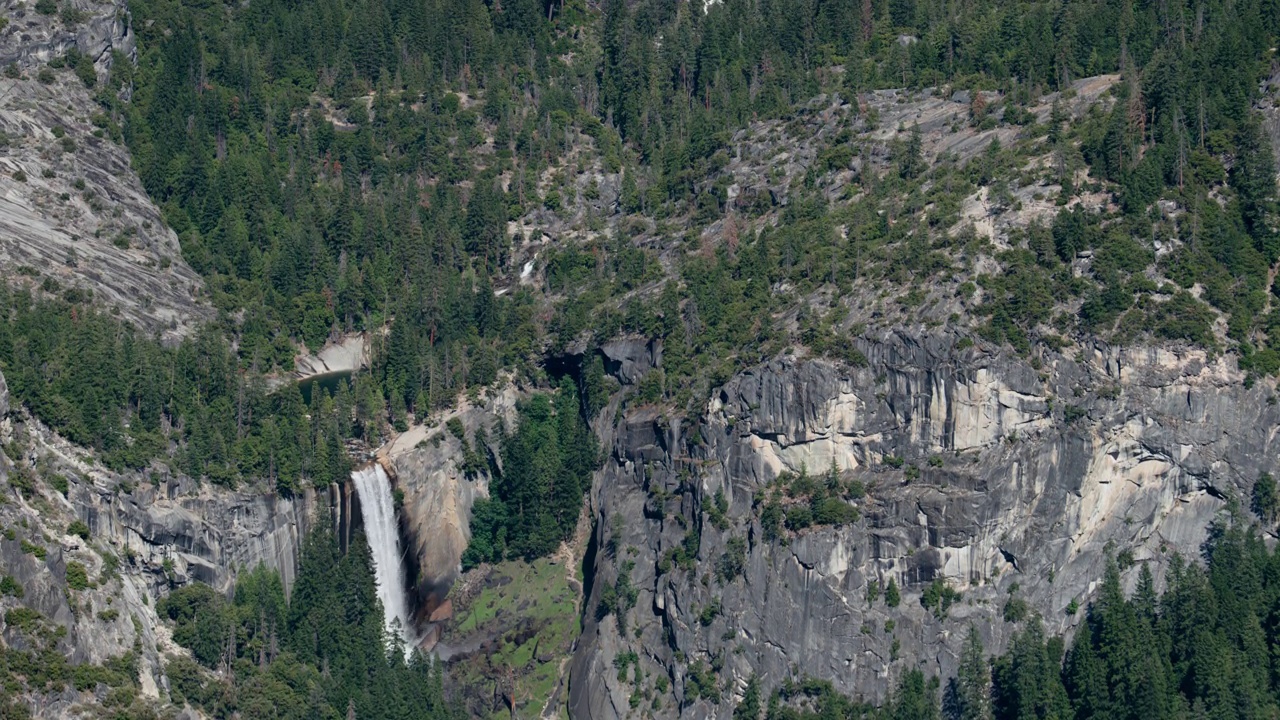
[156,523,457,720]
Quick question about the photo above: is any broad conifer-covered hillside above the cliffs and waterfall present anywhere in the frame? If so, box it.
[4,0,1280,487]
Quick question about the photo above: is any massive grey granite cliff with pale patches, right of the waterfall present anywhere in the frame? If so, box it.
[570,332,1259,719]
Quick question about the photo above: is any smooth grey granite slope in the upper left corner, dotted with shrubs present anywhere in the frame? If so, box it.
[0,0,211,340]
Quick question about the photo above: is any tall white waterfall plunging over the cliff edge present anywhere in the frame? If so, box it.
[351,462,415,655]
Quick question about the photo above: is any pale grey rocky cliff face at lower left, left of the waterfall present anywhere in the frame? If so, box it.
[0,397,340,717]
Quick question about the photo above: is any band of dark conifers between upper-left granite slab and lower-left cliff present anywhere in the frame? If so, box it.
[0,284,353,493]
